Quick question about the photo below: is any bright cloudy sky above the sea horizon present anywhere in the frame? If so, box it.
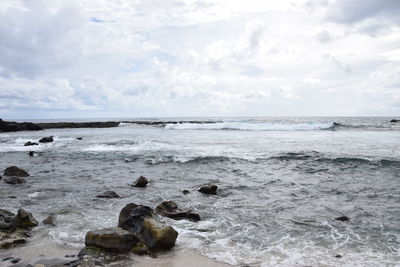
[0,0,400,119]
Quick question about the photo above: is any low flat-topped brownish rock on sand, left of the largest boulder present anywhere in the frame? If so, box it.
[85,227,140,252]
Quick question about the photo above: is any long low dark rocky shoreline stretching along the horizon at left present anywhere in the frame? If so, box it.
[0,119,219,132]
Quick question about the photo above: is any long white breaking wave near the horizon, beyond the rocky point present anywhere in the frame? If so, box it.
[165,122,335,131]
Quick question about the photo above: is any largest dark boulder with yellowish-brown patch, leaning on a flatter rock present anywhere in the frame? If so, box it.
[118,203,178,251]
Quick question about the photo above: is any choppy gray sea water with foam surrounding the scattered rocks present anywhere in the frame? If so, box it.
[0,118,400,266]
